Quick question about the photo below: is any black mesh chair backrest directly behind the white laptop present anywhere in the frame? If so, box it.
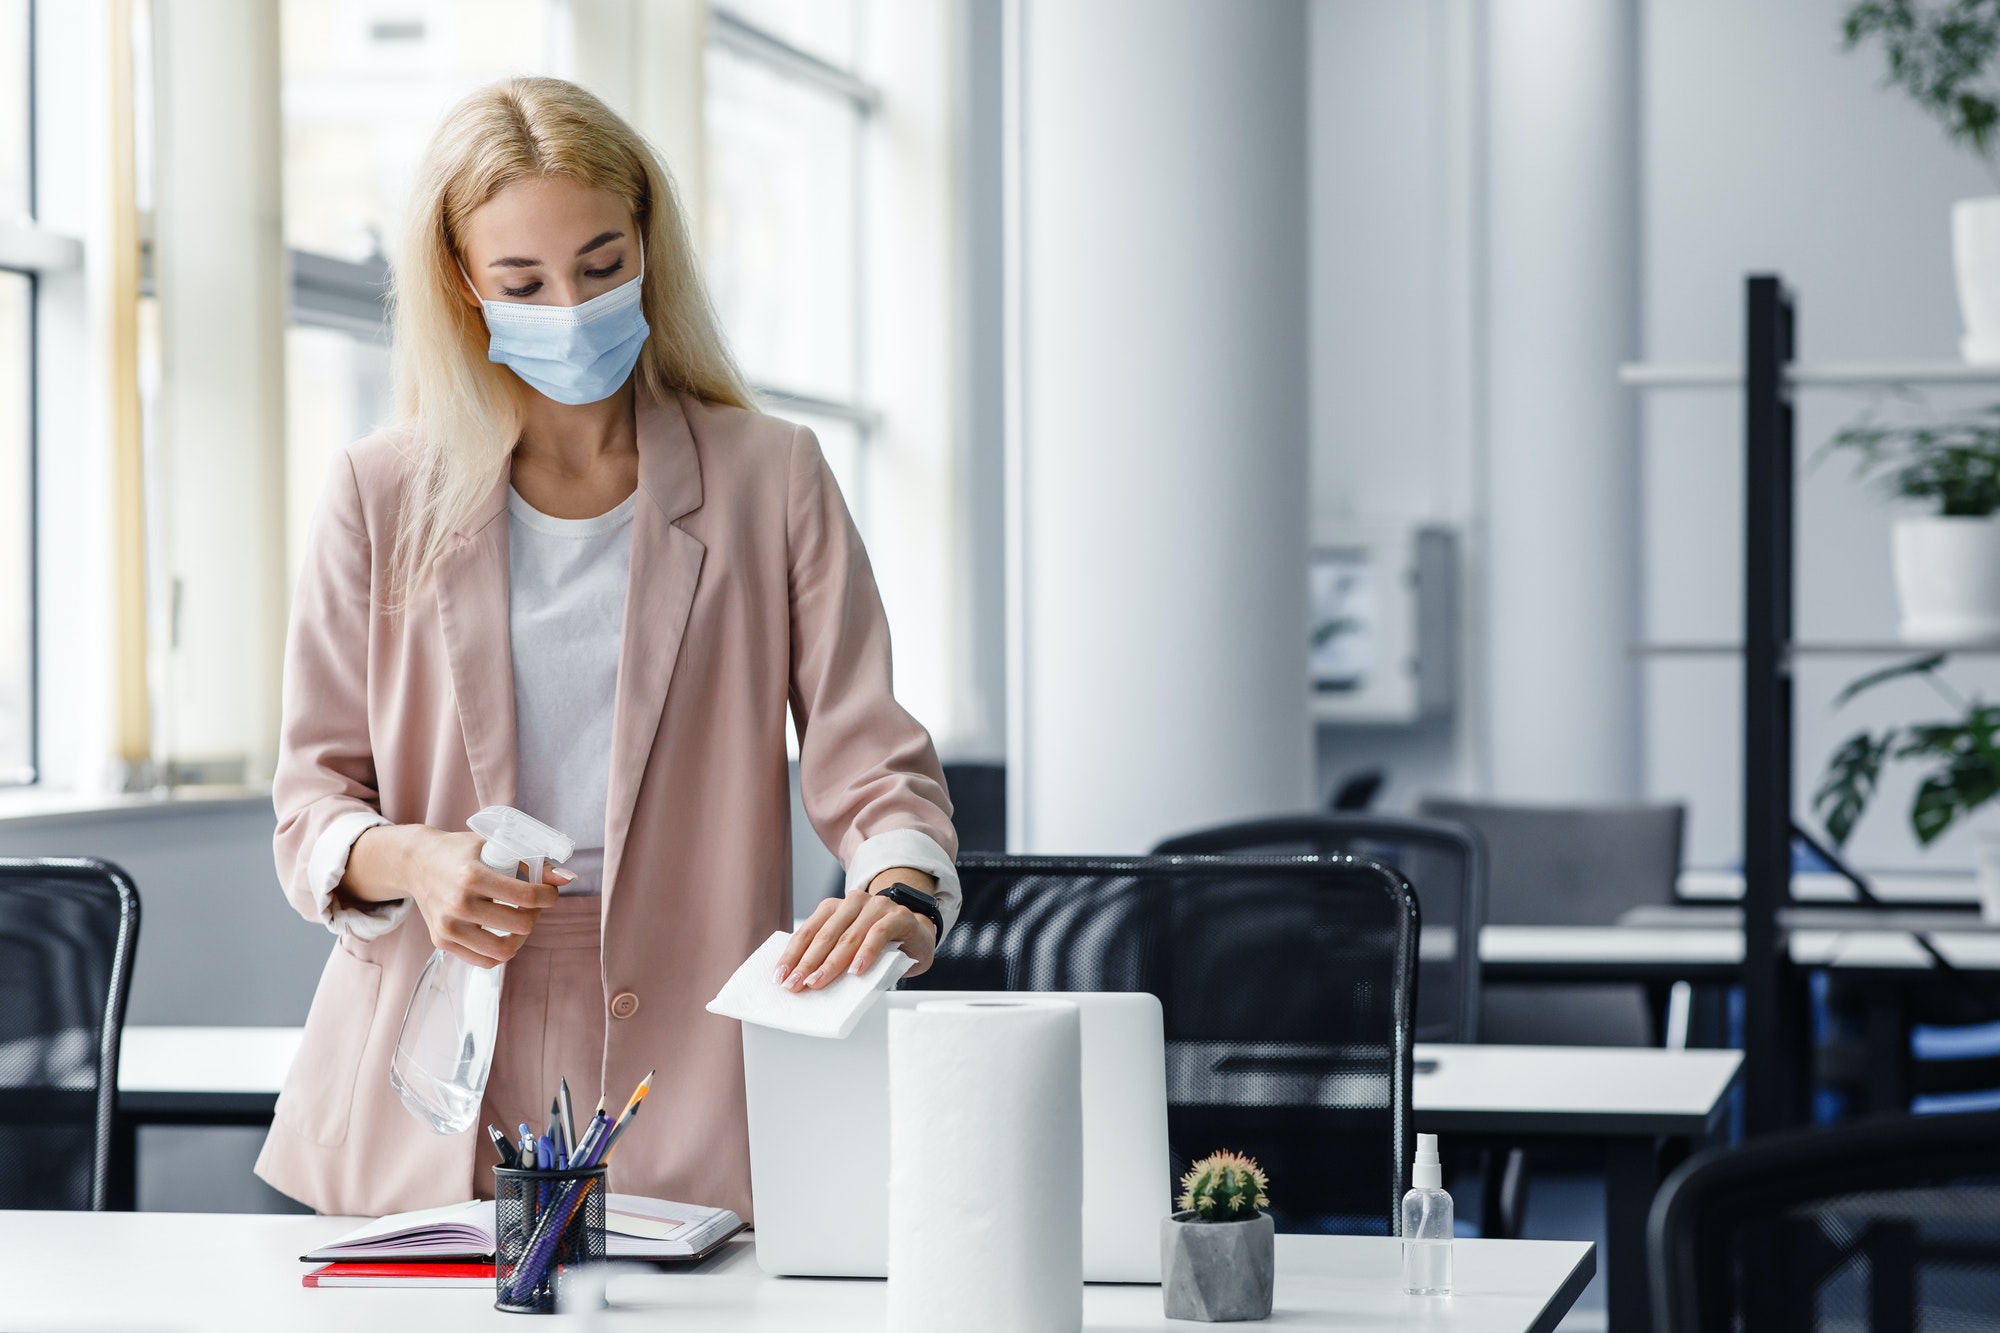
[906,857,1418,1235]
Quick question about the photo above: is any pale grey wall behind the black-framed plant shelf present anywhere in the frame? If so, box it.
[1640,0,2000,867]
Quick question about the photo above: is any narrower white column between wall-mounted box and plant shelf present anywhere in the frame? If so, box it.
[1486,0,1640,801]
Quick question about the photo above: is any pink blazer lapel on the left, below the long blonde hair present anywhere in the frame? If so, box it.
[434,472,516,805]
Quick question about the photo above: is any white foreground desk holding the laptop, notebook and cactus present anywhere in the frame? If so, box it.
[0,1213,1594,1333]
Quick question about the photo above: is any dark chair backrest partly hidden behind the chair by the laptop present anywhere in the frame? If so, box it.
[1152,815,1486,1041]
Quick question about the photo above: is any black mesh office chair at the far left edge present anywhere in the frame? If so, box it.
[0,859,138,1209]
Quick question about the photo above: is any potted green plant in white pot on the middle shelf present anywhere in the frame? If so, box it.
[1826,406,2000,644]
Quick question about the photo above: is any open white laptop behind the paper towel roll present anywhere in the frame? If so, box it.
[744,991,1174,1283]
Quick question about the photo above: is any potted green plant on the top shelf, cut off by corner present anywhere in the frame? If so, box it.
[1842,0,2000,362]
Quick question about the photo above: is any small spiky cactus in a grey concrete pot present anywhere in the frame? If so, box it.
[1160,1153,1276,1323]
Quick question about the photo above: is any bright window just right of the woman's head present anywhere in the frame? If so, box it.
[704,0,880,532]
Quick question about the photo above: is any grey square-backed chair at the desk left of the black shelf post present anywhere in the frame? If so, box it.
[1420,797,1686,1047]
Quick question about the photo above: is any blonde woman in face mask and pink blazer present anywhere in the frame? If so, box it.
[258,78,958,1219]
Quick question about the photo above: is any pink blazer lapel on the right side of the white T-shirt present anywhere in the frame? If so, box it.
[604,394,706,907]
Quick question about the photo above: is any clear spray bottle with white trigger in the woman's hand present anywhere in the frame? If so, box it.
[388,805,576,1135]
